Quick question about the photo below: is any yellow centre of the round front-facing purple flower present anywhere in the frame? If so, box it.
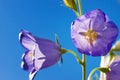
[85,29,98,46]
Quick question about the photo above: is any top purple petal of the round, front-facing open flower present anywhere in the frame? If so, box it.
[89,9,108,32]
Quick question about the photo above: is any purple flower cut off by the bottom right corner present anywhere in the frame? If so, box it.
[106,61,120,80]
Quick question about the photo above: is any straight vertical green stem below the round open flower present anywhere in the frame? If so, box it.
[82,54,86,80]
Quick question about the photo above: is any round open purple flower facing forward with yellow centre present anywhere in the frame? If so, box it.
[71,9,118,56]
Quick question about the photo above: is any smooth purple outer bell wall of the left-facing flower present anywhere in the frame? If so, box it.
[35,37,61,68]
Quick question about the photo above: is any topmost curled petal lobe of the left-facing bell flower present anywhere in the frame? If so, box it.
[19,30,35,50]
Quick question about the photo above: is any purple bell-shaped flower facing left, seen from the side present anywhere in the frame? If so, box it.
[19,30,61,80]
